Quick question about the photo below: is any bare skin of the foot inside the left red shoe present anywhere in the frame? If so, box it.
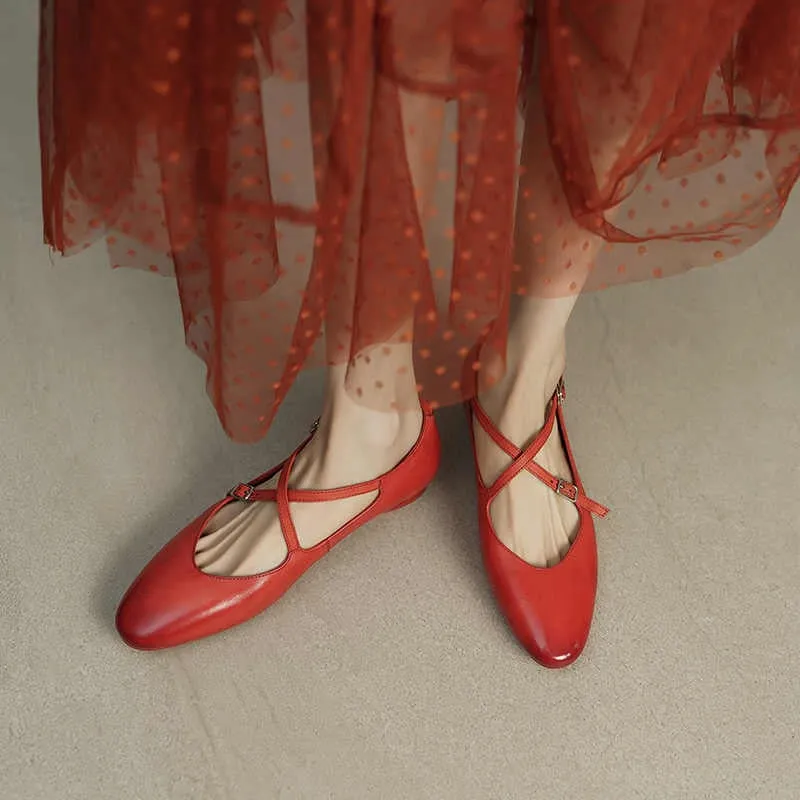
[195,401,422,576]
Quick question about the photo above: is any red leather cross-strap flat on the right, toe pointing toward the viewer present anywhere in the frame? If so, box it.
[467,381,608,667]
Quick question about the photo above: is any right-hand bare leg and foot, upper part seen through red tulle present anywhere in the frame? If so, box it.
[474,81,600,567]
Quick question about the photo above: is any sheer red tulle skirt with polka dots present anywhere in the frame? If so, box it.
[40,0,800,441]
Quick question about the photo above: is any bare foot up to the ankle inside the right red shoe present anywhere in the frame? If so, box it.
[472,352,579,567]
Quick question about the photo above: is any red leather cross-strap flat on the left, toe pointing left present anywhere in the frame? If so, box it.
[116,407,441,650]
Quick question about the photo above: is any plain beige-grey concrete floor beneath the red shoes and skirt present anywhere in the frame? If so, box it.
[0,0,800,800]
